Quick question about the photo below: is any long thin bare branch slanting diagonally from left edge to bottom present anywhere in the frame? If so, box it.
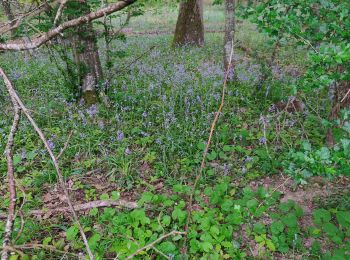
[0,68,95,260]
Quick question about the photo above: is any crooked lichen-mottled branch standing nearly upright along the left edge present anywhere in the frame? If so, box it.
[0,74,21,260]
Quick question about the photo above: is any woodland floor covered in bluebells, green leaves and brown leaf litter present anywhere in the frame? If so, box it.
[0,2,350,259]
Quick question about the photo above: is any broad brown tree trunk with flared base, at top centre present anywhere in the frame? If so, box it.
[174,0,204,46]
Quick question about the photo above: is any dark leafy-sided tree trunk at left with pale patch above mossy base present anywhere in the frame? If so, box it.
[72,2,103,105]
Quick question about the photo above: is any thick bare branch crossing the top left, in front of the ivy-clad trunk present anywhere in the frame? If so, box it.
[0,0,136,51]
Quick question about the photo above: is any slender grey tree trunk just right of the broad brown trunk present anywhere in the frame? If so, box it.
[224,0,236,75]
